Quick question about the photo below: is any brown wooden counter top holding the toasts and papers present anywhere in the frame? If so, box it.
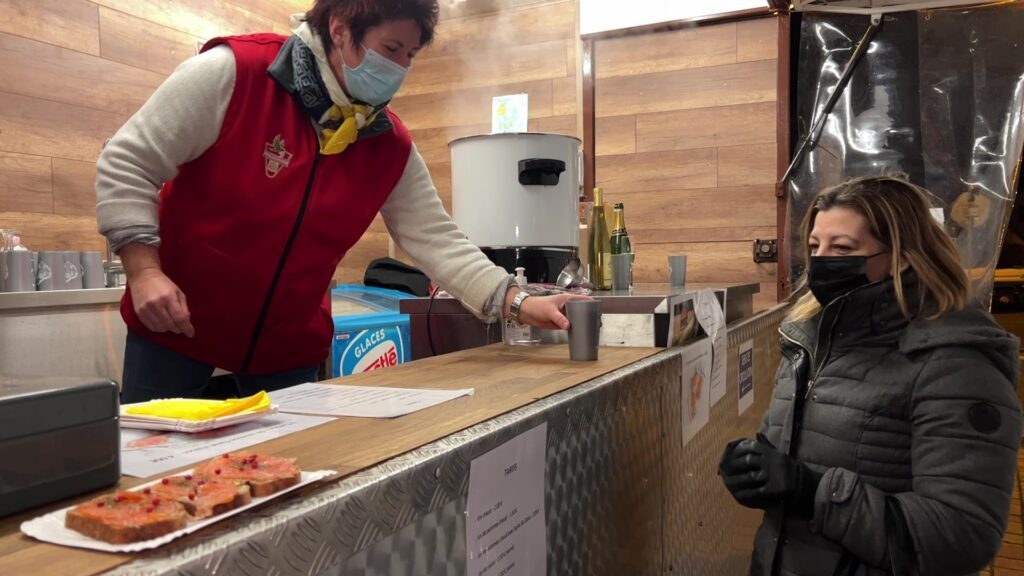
[0,344,662,575]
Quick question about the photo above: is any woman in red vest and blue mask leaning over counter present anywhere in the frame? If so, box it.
[96,0,569,403]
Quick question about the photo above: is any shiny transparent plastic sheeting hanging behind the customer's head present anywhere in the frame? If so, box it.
[787,4,1024,301]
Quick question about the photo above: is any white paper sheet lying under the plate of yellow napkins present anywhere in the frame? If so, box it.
[121,414,334,478]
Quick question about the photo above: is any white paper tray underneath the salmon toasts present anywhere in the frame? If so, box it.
[22,470,338,552]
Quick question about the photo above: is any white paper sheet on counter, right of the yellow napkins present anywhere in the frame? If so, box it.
[270,382,473,418]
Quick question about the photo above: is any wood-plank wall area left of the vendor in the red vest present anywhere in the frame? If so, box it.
[0,0,312,250]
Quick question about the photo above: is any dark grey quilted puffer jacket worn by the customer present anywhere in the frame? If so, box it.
[752,273,1021,576]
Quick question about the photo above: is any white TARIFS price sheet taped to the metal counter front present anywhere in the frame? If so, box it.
[466,423,548,576]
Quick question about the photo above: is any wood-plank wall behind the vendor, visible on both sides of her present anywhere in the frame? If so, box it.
[0,0,578,282]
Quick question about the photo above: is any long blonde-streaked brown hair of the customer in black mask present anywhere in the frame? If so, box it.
[790,174,971,320]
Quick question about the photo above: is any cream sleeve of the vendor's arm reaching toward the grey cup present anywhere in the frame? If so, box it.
[381,147,508,320]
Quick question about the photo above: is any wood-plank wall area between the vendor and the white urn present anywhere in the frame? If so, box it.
[382,0,581,279]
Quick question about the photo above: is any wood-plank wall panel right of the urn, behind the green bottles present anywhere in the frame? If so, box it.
[594,17,777,308]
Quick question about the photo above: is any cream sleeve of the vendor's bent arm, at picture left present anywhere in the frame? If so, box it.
[96,45,234,251]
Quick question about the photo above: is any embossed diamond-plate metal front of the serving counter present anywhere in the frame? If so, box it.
[113,310,782,576]
